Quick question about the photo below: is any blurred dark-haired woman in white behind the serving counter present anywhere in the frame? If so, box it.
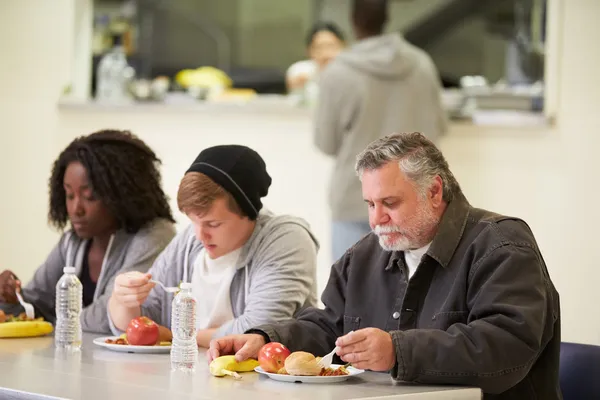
[286,22,346,99]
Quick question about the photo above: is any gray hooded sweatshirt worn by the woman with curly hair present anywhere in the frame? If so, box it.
[2,219,175,333]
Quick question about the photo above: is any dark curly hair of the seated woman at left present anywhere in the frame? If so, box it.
[48,130,174,233]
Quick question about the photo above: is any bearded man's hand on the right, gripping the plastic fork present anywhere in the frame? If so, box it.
[335,328,396,371]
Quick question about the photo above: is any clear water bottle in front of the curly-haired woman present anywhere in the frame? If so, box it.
[54,267,83,350]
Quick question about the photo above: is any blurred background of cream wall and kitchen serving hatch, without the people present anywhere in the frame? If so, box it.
[0,0,600,344]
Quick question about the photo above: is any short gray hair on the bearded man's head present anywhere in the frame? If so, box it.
[355,132,462,202]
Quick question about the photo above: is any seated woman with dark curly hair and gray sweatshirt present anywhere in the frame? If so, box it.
[0,130,175,332]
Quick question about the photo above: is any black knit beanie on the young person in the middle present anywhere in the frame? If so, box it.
[186,145,271,220]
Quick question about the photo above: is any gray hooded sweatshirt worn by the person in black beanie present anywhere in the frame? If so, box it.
[109,210,319,337]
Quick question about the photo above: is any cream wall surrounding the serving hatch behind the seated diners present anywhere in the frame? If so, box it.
[0,0,600,344]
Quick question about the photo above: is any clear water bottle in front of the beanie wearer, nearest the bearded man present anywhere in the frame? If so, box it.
[171,282,198,372]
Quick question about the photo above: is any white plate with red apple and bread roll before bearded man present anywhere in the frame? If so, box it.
[254,342,365,383]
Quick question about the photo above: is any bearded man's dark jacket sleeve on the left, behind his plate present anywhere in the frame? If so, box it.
[246,253,349,355]
